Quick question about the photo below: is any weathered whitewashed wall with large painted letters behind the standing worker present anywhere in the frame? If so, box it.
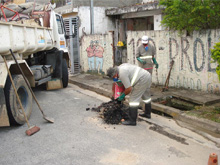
[127,30,220,93]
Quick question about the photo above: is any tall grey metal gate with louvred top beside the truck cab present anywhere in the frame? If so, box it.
[64,17,80,74]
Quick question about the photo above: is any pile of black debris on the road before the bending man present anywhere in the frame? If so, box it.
[92,100,128,124]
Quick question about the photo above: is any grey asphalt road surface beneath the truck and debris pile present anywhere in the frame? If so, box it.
[0,84,220,165]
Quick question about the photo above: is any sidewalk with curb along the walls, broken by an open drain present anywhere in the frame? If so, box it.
[69,74,220,138]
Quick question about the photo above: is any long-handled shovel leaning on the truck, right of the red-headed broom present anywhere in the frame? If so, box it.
[9,49,54,123]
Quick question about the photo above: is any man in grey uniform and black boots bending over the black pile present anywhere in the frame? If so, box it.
[107,63,152,126]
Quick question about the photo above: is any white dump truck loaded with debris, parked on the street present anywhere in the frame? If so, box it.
[0,10,69,126]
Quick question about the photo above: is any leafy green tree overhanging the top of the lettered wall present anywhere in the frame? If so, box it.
[159,0,220,33]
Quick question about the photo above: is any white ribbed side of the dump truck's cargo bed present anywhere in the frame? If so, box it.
[0,22,54,57]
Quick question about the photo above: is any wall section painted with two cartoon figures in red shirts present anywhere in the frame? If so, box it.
[80,33,113,74]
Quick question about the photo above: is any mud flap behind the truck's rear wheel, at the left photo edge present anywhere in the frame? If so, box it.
[0,88,10,127]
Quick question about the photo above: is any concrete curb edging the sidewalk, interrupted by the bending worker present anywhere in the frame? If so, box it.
[69,79,220,137]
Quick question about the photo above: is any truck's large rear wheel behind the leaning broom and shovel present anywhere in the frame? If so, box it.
[4,75,32,125]
